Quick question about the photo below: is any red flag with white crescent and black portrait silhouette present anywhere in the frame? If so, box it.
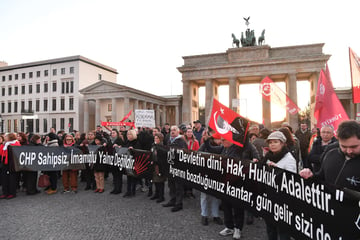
[209,99,250,147]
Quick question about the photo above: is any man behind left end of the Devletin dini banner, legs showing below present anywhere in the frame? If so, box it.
[163,126,187,212]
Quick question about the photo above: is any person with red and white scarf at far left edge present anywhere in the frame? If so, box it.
[0,133,20,199]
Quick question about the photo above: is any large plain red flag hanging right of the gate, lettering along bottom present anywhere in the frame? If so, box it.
[314,66,349,131]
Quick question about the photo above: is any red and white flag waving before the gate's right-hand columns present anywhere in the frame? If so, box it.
[260,77,300,114]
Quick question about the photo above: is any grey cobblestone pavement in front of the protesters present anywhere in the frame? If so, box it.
[0,175,266,240]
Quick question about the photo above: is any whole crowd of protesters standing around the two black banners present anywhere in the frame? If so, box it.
[0,120,360,240]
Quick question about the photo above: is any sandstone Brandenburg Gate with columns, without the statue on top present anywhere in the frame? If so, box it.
[178,43,330,129]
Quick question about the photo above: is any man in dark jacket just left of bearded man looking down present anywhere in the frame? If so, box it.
[307,125,337,172]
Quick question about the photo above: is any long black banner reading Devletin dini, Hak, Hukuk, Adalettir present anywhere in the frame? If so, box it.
[163,145,360,240]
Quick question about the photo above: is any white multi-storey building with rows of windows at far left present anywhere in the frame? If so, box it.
[0,56,117,134]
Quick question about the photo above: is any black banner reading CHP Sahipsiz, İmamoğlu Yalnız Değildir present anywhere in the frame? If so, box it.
[11,145,153,178]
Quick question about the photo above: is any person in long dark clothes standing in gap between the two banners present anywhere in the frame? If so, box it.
[150,132,168,203]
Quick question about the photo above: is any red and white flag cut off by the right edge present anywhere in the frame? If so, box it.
[349,48,360,103]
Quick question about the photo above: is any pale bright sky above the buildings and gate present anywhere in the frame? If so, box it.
[0,0,360,122]
